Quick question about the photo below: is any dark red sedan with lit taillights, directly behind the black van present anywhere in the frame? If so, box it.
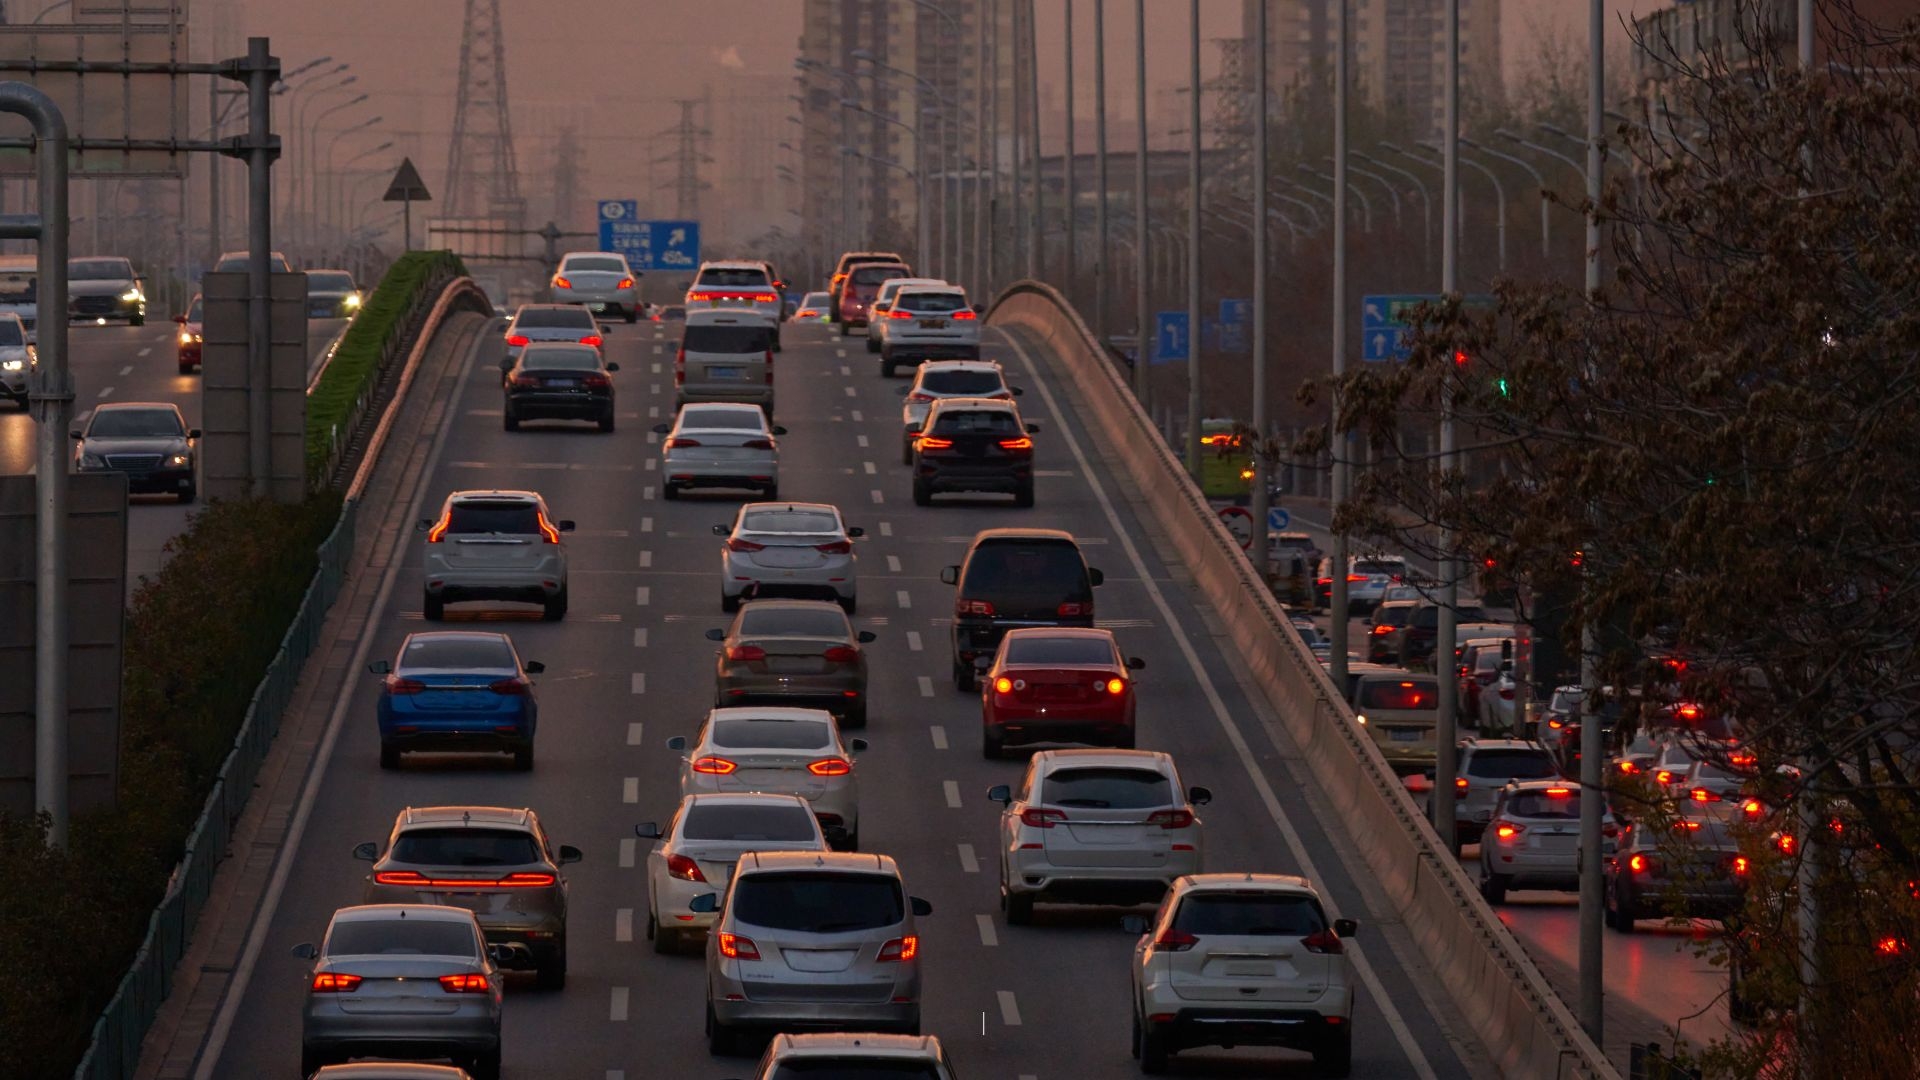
[979,626,1146,757]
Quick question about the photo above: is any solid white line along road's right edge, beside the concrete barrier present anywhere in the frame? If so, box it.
[1006,330,1436,1080]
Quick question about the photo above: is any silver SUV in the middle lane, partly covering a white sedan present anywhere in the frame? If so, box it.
[691,851,933,1055]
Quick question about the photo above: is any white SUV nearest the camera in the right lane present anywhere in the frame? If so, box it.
[1125,874,1359,1076]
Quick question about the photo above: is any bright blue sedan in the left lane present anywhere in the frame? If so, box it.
[367,630,545,773]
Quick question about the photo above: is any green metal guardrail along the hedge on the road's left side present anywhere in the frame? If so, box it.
[73,500,359,1080]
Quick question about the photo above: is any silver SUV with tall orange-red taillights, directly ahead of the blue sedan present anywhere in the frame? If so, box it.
[419,490,574,623]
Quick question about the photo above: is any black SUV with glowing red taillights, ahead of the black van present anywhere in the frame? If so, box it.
[914,398,1041,505]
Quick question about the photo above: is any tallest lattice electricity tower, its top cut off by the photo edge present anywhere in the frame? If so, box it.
[447,0,526,223]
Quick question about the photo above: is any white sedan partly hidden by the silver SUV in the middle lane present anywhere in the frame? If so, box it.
[634,792,828,953]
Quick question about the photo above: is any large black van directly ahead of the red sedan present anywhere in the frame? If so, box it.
[941,528,1104,692]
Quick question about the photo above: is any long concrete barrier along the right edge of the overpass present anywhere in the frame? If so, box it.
[987,282,1619,1078]
